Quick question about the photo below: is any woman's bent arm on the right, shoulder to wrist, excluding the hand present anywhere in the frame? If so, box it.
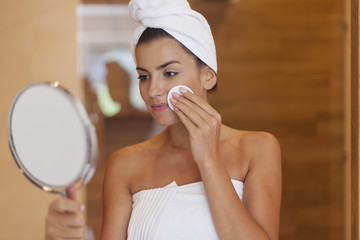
[199,133,281,240]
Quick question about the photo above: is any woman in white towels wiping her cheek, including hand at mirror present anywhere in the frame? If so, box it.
[46,0,281,240]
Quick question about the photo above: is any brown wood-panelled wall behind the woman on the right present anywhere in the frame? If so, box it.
[199,0,345,240]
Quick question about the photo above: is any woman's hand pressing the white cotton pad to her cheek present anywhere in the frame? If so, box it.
[170,88,221,164]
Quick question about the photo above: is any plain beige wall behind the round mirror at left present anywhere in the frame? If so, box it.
[0,0,81,240]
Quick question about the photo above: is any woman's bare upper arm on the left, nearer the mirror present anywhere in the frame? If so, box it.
[100,150,132,240]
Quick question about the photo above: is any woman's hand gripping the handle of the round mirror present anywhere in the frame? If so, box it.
[45,189,86,240]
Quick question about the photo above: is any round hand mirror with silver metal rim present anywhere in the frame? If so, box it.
[8,82,97,197]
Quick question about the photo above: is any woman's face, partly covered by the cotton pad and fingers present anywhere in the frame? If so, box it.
[135,38,207,126]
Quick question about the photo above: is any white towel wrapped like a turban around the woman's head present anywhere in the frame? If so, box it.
[129,0,217,72]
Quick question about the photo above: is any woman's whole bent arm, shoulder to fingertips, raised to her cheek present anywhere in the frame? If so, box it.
[173,88,281,240]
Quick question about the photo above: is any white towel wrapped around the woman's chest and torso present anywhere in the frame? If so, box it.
[128,179,244,240]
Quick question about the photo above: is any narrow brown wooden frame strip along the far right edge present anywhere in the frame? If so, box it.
[351,0,359,239]
